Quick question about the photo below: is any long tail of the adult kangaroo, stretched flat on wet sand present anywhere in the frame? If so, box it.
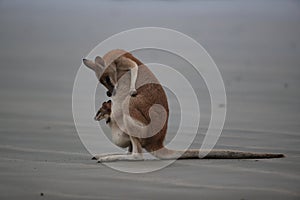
[151,147,285,160]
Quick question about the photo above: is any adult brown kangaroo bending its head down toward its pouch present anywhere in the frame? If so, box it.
[83,49,284,162]
